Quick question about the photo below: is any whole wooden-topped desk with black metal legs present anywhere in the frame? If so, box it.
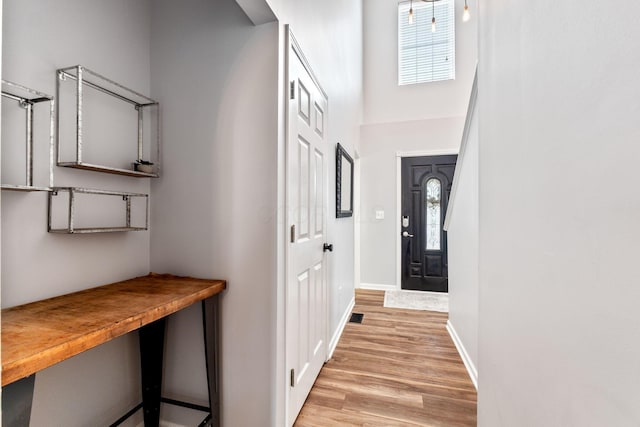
[2,273,226,427]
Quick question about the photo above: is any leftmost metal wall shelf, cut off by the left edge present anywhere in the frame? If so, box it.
[0,80,55,191]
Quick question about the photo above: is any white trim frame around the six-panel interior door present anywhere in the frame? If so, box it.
[282,27,335,425]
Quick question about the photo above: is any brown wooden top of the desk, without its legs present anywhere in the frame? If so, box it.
[2,273,226,387]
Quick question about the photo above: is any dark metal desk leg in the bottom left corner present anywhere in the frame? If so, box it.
[2,374,36,427]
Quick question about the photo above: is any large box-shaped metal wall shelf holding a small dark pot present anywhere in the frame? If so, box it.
[56,65,160,178]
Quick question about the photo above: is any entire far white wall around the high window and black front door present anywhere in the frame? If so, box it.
[359,0,477,287]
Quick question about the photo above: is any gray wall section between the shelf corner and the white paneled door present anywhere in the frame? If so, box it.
[151,0,278,426]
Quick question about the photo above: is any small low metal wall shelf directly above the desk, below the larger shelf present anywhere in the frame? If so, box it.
[47,187,149,234]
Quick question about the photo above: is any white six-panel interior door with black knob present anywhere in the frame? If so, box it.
[286,33,328,426]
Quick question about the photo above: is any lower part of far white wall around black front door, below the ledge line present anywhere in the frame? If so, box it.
[359,117,464,286]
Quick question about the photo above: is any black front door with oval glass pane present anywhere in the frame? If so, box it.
[400,155,458,292]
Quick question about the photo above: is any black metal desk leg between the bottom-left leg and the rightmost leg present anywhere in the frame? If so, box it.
[138,318,166,427]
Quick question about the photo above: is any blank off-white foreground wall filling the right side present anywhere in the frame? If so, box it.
[478,0,640,427]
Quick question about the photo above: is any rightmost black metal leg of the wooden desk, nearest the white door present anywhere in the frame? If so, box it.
[202,295,220,427]
